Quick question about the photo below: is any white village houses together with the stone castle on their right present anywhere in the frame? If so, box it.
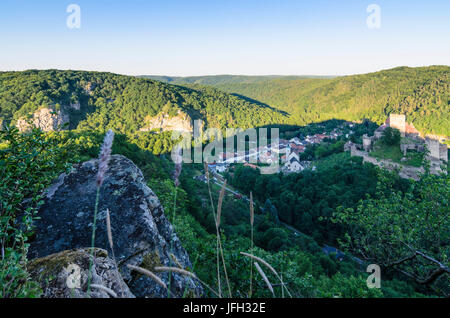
[203,114,448,179]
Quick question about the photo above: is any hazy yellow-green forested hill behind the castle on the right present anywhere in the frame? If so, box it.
[146,66,450,136]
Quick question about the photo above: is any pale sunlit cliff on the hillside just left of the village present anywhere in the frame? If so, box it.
[140,111,194,133]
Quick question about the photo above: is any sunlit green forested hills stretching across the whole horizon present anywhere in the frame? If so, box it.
[0,66,450,136]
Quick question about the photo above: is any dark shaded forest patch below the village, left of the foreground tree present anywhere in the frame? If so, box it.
[230,158,377,244]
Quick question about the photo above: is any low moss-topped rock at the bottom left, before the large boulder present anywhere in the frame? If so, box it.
[27,248,134,298]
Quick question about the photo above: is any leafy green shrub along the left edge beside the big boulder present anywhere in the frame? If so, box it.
[0,127,75,297]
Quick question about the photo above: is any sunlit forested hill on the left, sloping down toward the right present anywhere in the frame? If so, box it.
[0,70,287,133]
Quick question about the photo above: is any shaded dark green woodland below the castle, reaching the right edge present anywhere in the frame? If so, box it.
[228,153,450,295]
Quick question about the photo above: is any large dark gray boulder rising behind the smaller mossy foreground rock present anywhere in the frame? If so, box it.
[28,155,203,297]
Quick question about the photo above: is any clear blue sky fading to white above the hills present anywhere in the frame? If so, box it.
[0,0,450,76]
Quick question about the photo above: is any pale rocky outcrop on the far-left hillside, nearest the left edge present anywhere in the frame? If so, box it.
[16,107,69,132]
